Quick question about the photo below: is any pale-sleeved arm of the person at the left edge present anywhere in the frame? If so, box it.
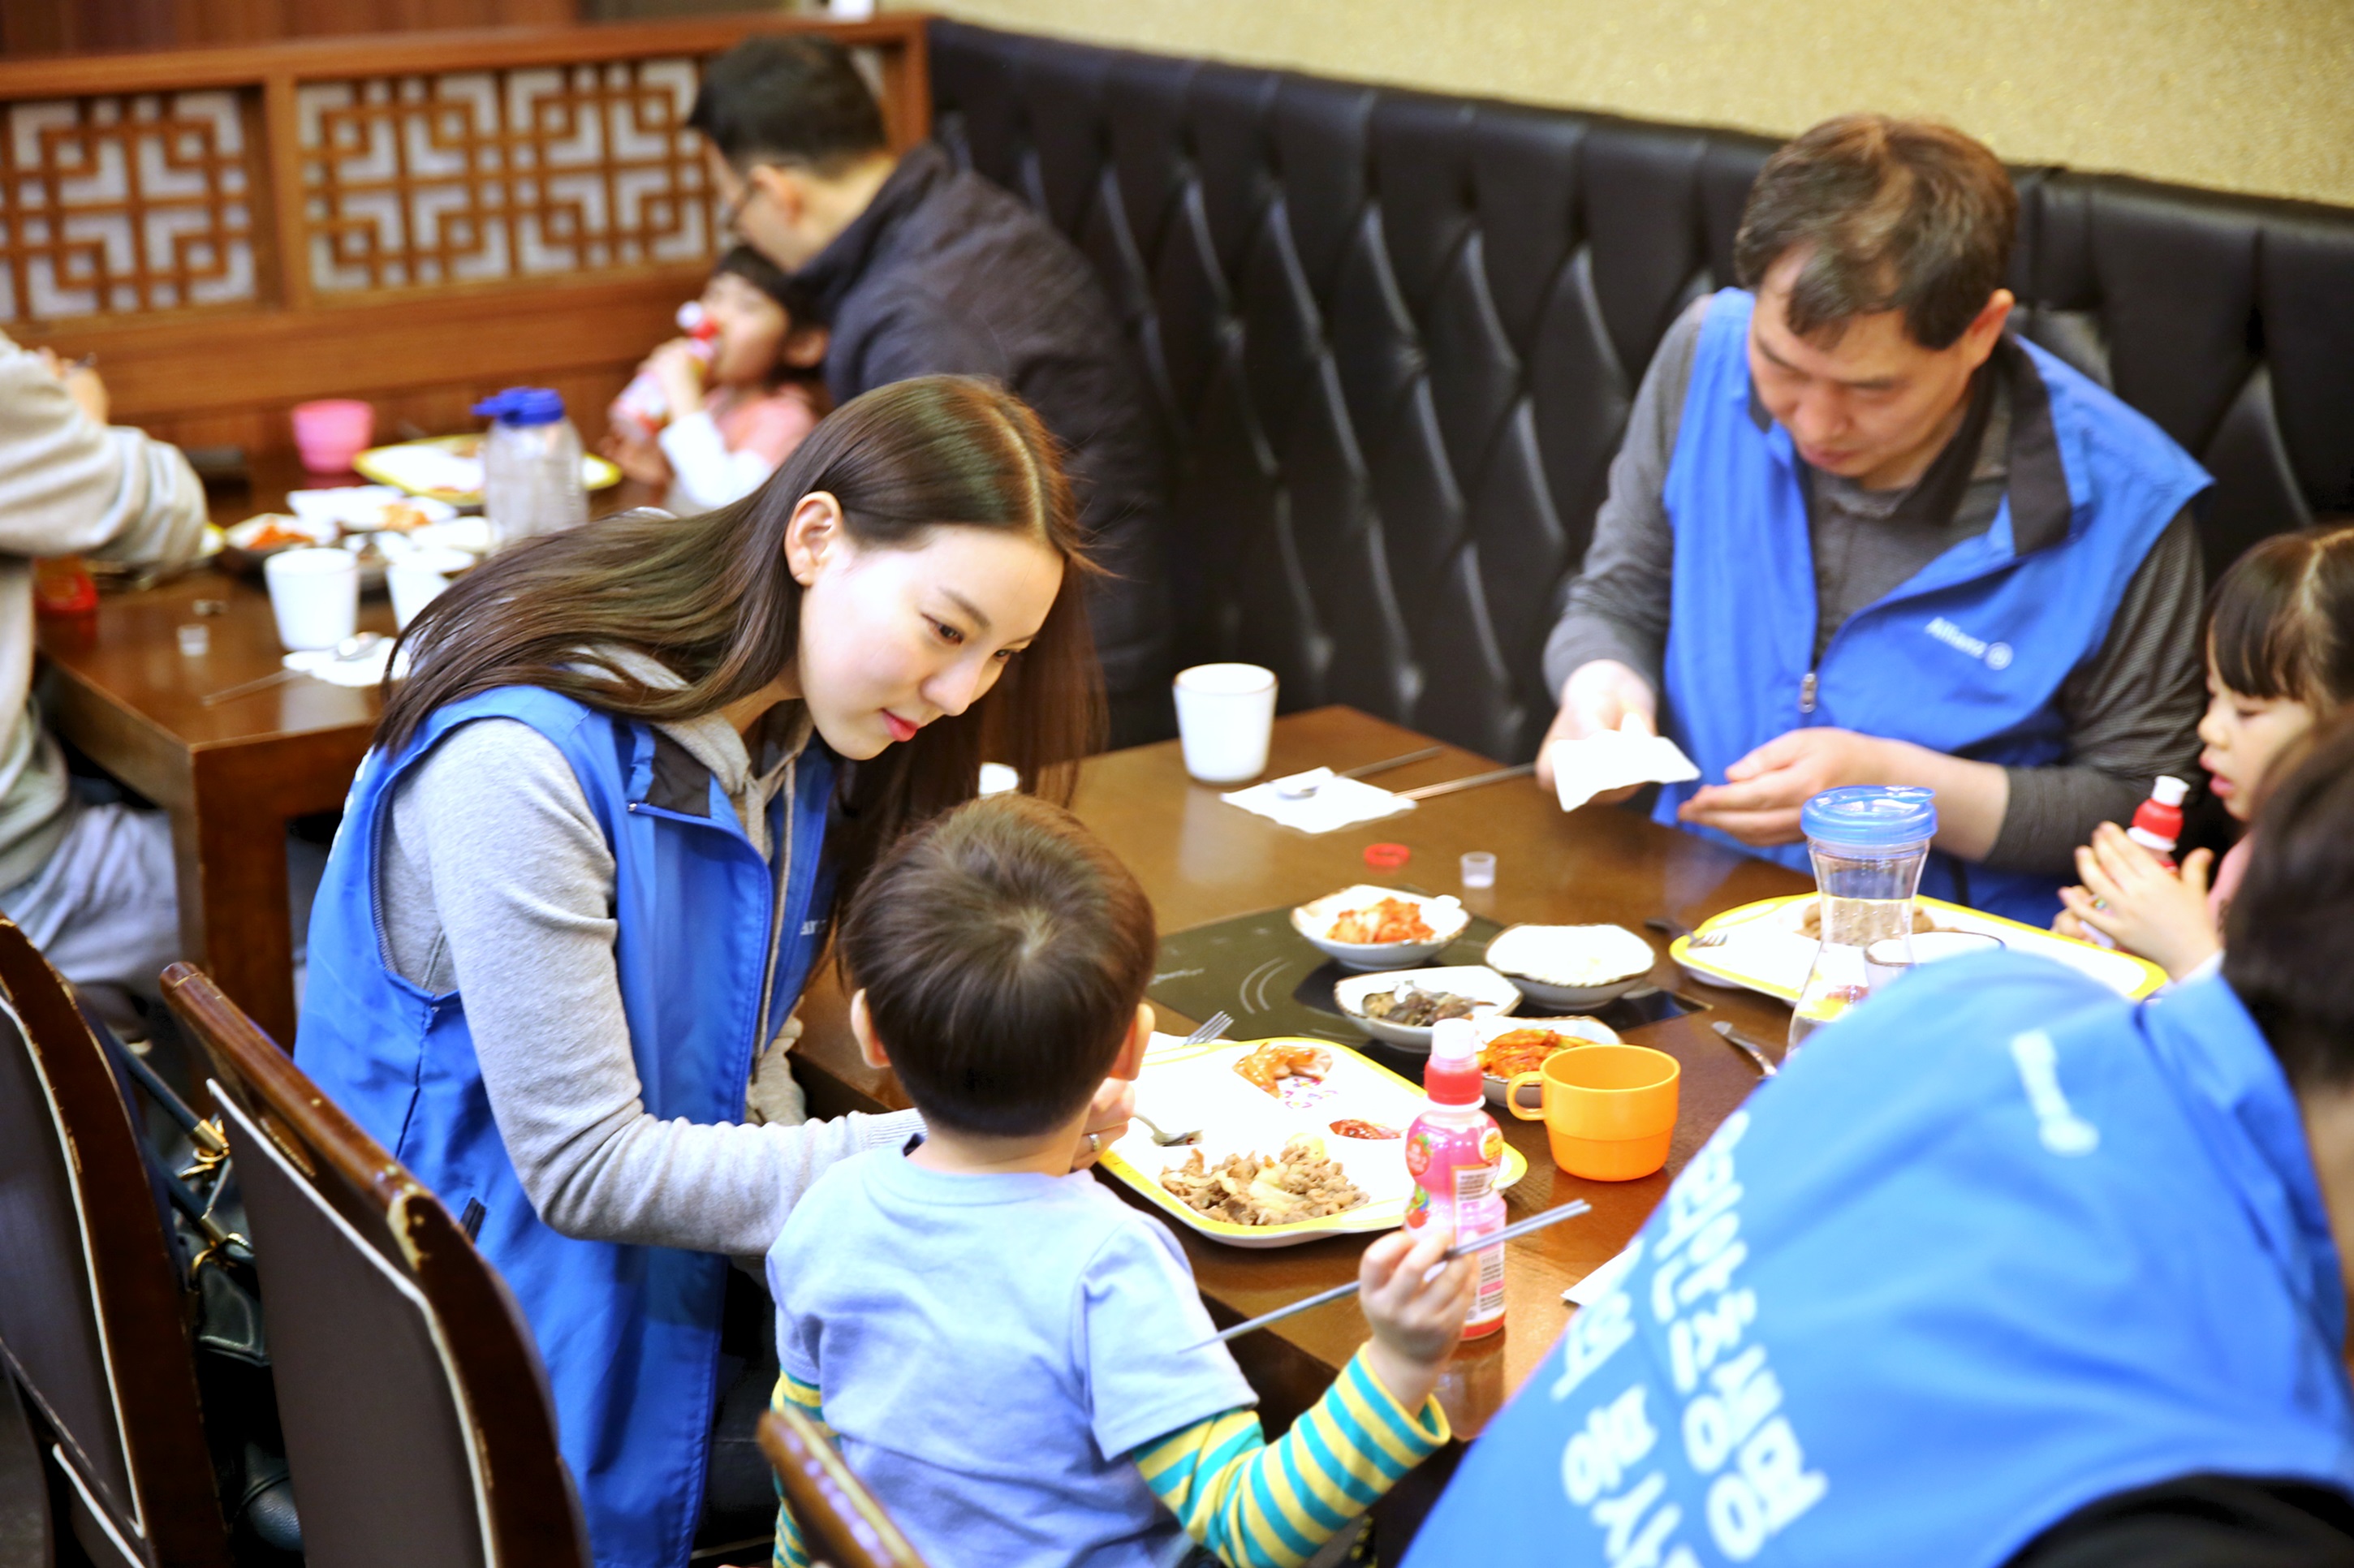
[0,337,205,565]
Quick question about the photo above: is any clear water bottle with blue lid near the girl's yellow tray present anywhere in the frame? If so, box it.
[1789,784,1938,1050]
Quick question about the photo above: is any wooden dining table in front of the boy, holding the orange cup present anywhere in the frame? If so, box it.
[795,706,1813,1556]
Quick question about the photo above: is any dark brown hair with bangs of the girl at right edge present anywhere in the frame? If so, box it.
[2208,518,2354,711]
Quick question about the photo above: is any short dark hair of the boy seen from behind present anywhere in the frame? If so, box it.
[840,796,1156,1137]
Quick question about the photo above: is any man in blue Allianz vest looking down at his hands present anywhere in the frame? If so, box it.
[1542,115,2208,925]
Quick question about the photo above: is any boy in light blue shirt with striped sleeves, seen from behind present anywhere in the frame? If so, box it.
[767,796,1473,1568]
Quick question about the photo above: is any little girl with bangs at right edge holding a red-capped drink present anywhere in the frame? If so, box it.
[2053,523,2354,980]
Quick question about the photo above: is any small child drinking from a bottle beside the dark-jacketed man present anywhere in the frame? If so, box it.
[605,245,829,515]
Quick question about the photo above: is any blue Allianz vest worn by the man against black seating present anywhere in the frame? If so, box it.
[1658,290,2208,925]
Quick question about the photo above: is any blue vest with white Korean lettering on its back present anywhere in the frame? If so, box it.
[1408,954,2354,1568]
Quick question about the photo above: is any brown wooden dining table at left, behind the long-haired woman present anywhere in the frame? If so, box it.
[37,445,645,1045]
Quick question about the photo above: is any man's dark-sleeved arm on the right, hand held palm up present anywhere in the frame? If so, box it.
[1681,510,2203,856]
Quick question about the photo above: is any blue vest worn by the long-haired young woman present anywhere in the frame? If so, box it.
[295,687,836,1568]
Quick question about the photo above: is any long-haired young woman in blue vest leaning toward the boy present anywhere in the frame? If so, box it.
[295,377,1125,1568]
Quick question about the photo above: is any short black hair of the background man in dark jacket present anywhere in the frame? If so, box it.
[688,33,890,174]
